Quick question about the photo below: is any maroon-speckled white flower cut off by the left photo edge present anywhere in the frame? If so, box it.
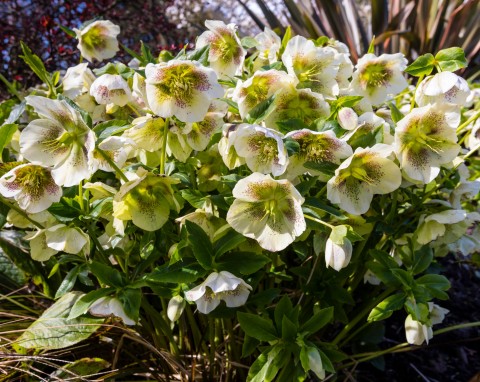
[0,164,62,214]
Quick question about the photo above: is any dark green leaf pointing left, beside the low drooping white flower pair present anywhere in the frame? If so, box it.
[146,259,206,284]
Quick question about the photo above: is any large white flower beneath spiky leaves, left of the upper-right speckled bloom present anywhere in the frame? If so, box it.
[282,36,340,98]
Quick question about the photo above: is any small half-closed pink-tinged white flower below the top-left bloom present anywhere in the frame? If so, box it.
[90,74,133,107]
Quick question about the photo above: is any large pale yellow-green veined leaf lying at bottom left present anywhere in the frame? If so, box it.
[13,292,104,350]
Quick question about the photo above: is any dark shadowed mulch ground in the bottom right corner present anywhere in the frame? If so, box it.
[356,255,480,382]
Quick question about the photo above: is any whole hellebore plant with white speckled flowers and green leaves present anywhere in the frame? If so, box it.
[0,17,480,382]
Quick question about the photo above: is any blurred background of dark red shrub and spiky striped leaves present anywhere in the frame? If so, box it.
[0,0,480,98]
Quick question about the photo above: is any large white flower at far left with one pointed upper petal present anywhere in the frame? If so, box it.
[20,96,95,187]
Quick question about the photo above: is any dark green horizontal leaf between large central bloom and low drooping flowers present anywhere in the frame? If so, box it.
[215,252,271,275]
